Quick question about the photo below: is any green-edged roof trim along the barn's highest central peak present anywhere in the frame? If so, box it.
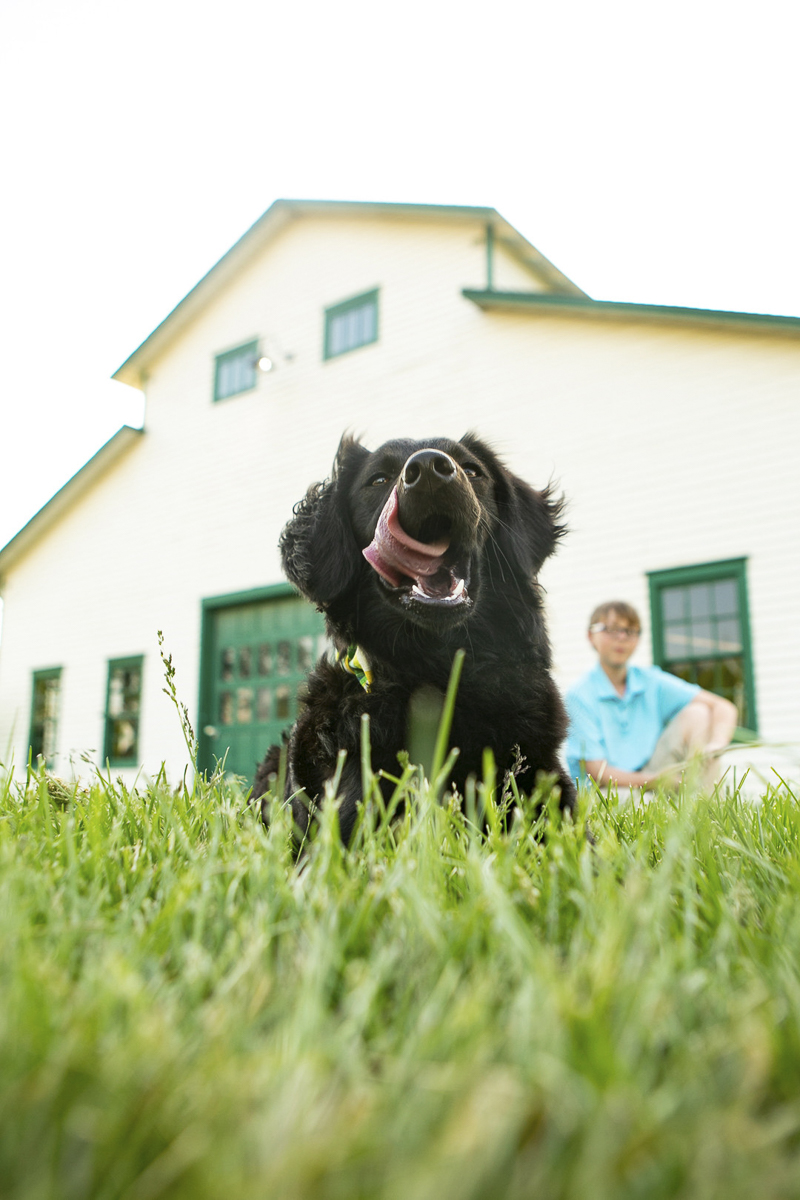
[114,199,588,388]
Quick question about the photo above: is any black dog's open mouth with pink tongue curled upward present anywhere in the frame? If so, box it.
[362,488,469,607]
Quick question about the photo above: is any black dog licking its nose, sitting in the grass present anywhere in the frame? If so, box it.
[253,433,575,842]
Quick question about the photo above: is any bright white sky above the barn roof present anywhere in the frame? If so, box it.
[0,0,800,546]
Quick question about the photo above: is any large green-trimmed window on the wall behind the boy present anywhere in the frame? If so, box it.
[649,558,757,730]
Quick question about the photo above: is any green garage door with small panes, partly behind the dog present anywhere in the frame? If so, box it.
[200,584,326,781]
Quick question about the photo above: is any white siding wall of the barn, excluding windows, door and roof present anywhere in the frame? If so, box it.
[0,217,800,778]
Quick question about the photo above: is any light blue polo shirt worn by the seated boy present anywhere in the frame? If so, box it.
[565,664,700,779]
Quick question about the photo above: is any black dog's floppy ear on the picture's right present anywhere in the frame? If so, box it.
[461,433,566,577]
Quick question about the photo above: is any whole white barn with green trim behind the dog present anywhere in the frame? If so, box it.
[0,200,800,781]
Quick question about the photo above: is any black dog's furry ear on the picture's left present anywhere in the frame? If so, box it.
[279,436,369,608]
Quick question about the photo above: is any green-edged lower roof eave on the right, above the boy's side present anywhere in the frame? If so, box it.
[462,288,800,337]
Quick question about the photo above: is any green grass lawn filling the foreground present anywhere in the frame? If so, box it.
[0,756,800,1200]
